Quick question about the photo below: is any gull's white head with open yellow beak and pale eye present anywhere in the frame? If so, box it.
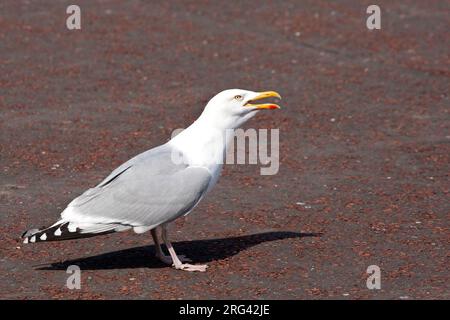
[202,89,281,128]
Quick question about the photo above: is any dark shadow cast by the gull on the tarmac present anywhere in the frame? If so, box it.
[38,231,321,270]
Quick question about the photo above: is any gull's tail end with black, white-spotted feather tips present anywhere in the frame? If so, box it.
[22,220,119,243]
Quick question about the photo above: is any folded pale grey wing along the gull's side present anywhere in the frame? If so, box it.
[62,147,211,227]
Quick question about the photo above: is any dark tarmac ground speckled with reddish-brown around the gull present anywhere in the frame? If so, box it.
[0,0,450,299]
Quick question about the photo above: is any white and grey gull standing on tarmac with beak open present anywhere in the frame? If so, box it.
[22,89,281,272]
